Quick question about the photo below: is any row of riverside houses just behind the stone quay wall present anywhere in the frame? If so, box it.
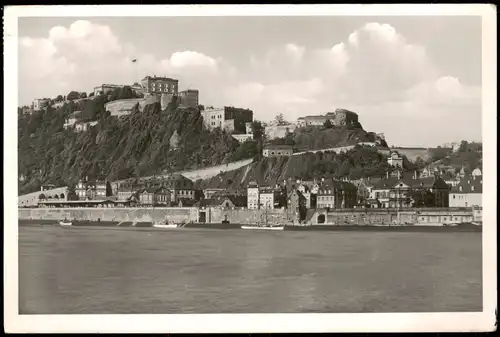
[33,167,482,214]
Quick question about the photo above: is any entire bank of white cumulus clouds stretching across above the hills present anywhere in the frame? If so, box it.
[19,20,481,145]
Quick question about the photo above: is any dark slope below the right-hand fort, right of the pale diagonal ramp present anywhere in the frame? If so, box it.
[199,146,416,189]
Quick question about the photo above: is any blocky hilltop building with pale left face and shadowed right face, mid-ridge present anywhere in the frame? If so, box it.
[201,106,253,133]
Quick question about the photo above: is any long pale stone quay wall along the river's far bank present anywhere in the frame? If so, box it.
[18,207,482,225]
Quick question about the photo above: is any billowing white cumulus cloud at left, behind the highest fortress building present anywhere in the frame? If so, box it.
[19,20,223,104]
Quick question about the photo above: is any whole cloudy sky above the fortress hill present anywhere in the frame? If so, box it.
[18,16,482,146]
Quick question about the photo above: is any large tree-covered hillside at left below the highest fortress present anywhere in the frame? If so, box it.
[18,96,239,194]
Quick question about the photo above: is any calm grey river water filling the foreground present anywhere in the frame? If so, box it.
[19,227,482,314]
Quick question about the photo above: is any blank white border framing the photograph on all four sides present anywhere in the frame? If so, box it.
[4,4,497,333]
